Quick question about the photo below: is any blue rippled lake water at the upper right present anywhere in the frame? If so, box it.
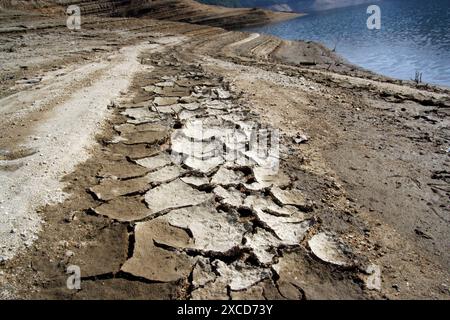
[246,0,450,87]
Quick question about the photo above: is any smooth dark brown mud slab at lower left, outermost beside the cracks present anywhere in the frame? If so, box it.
[70,223,128,277]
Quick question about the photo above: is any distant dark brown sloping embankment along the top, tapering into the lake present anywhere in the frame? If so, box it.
[0,0,299,28]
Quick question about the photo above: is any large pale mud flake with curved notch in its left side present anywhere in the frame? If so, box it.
[164,206,245,253]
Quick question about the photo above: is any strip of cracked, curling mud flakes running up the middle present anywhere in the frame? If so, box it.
[83,50,366,299]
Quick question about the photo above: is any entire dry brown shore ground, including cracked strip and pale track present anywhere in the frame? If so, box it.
[0,10,450,299]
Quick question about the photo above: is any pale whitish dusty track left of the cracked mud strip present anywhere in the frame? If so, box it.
[0,40,178,260]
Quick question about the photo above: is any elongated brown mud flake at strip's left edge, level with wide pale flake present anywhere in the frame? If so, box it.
[89,177,149,201]
